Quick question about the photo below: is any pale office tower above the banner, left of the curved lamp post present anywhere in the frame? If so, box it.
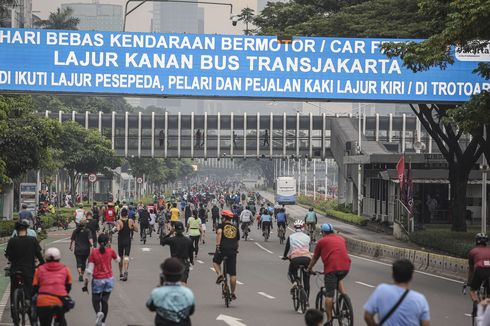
[61,3,123,31]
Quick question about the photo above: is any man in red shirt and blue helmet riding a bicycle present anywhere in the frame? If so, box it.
[308,223,351,325]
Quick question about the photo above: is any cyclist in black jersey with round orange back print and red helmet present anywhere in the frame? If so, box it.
[213,210,240,300]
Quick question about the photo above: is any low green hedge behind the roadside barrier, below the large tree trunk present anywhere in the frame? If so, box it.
[410,229,475,258]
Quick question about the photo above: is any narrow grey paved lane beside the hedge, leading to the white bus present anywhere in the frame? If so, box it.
[260,191,425,250]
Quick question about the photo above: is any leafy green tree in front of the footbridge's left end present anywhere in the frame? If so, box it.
[59,121,120,198]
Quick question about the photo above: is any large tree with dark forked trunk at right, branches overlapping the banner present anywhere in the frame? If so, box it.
[385,0,490,231]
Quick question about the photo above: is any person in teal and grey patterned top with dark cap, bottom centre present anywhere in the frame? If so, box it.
[146,258,196,326]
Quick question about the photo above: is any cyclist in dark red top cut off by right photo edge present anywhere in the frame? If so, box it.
[468,233,490,303]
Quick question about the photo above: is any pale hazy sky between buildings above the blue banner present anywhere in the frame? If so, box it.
[32,0,257,34]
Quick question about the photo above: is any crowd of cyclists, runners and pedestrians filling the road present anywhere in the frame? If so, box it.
[17,177,490,326]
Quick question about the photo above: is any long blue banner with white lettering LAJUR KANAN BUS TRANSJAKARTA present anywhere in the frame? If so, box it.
[0,29,490,103]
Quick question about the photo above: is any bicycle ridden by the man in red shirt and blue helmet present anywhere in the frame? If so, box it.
[312,272,354,326]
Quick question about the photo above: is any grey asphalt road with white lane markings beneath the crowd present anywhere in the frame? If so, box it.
[0,215,471,326]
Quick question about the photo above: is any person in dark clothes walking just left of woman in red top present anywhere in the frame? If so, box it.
[70,217,93,282]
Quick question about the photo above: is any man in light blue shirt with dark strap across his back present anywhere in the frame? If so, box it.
[364,259,430,326]
